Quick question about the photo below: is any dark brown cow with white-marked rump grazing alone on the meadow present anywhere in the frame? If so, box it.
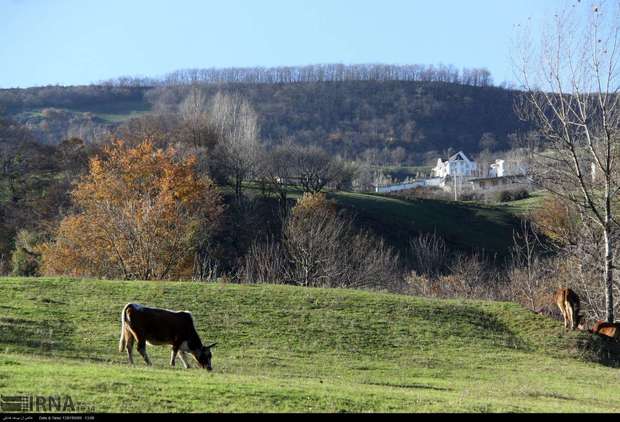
[119,303,217,371]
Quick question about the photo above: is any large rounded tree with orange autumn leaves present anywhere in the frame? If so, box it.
[41,141,223,280]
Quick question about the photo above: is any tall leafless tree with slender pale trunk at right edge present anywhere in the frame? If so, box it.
[517,1,620,322]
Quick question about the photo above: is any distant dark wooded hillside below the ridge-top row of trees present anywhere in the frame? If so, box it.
[0,80,527,160]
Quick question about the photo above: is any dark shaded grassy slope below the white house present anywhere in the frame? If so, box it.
[331,193,519,256]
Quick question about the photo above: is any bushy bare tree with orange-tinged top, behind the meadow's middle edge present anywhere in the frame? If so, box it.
[241,194,403,291]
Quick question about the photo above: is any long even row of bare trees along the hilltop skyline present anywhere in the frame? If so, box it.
[102,64,493,87]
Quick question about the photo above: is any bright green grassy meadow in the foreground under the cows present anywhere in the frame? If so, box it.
[0,278,620,412]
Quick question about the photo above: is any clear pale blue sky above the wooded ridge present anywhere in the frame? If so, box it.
[0,0,562,88]
